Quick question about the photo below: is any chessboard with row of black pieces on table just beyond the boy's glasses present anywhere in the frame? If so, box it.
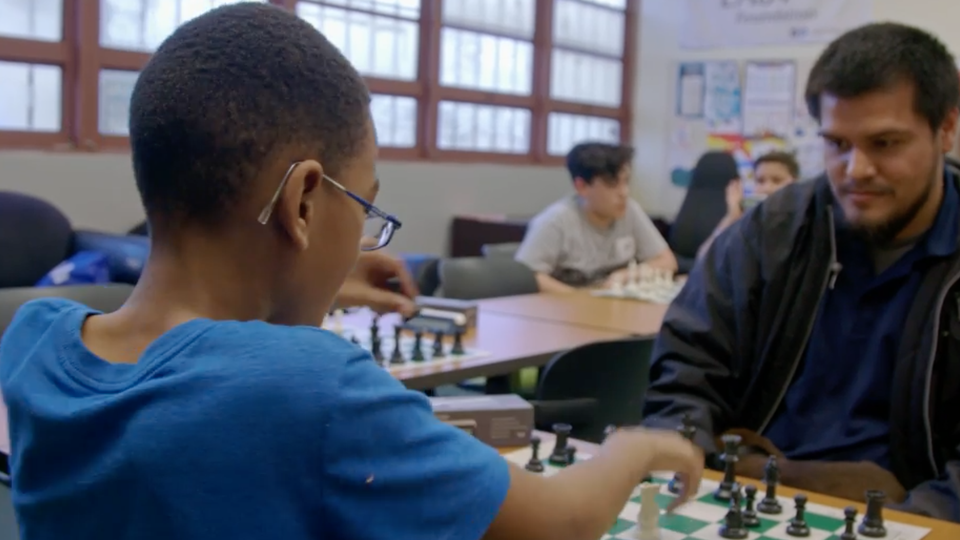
[323,316,490,370]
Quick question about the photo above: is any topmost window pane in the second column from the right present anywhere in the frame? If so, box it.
[443,0,536,39]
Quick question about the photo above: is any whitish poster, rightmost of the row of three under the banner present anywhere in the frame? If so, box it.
[743,61,797,137]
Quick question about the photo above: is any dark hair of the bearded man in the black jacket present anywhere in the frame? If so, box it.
[805,22,960,130]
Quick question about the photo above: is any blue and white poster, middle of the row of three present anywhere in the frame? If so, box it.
[703,60,743,133]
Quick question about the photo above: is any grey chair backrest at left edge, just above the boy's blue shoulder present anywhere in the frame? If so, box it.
[0,284,133,339]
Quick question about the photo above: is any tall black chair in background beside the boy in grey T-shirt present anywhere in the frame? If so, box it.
[668,152,740,274]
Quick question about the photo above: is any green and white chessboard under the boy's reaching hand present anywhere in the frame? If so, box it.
[505,446,930,540]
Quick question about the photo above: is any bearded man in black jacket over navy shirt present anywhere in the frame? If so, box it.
[644,23,960,522]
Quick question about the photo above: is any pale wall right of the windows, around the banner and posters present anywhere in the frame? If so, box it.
[634,0,960,218]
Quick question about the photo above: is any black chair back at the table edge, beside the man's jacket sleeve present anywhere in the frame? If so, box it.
[532,338,653,443]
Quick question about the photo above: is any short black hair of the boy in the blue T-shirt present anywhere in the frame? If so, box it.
[130,3,370,227]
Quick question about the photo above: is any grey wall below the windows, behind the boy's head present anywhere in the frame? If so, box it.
[0,152,570,254]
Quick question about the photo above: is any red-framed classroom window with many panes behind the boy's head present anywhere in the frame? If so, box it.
[0,0,639,165]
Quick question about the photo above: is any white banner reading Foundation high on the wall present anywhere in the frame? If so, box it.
[671,0,873,49]
